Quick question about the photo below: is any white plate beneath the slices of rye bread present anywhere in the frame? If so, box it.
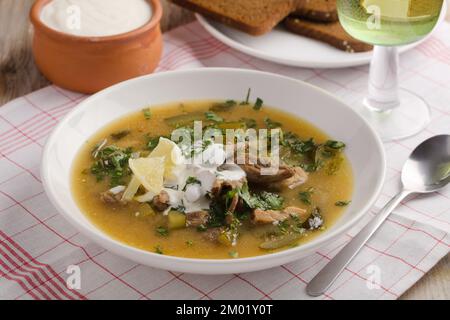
[196,2,447,68]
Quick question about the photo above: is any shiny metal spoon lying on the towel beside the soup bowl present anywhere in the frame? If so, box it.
[306,135,450,297]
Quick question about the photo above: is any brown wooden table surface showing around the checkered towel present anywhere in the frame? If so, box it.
[0,0,450,299]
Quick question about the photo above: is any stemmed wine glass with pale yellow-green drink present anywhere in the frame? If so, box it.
[337,0,444,141]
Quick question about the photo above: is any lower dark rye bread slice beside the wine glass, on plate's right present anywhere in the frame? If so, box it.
[285,17,373,52]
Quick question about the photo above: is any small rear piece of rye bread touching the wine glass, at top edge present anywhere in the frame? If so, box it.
[292,0,338,22]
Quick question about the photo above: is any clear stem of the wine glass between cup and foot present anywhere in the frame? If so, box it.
[364,46,400,112]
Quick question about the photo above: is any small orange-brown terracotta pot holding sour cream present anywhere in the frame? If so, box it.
[30,0,162,93]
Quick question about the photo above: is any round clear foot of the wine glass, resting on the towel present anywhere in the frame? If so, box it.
[359,89,430,141]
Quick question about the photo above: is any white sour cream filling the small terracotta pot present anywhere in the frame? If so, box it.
[40,0,152,37]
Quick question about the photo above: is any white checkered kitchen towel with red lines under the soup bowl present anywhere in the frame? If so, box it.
[0,22,450,299]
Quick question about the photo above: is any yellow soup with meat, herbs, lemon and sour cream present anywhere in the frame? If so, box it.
[73,99,353,259]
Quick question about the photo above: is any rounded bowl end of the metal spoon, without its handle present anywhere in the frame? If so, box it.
[402,135,450,193]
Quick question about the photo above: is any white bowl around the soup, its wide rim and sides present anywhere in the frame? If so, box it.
[41,68,386,274]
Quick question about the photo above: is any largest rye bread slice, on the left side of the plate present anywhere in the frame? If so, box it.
[171,0,305,35]
